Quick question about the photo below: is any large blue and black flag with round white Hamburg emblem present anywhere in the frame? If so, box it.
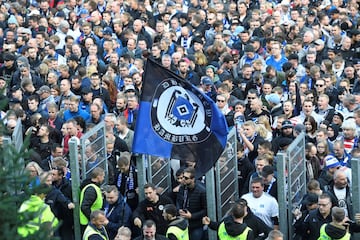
[133,59,228,176]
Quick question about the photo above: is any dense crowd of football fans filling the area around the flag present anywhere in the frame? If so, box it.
[0,0,360,240]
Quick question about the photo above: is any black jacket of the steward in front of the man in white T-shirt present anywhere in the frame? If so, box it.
[209,216,255,240]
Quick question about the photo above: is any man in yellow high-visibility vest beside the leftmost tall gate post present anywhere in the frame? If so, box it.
[80,167,105,232]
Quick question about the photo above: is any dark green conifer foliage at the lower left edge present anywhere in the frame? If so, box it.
[0,124,55,240]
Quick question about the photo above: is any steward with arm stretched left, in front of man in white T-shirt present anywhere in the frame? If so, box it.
[202,202,255,240]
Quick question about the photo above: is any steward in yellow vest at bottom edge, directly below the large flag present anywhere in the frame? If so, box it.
[163,204,189,240]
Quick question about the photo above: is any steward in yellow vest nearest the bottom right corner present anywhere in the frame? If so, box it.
[318,207,351,240]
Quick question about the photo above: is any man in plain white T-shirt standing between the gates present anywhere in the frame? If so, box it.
[241,178,279,229]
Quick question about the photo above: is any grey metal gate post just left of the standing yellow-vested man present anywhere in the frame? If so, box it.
[69,137,80,240]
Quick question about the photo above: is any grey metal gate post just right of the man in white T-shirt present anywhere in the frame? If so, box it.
[276,153,289,240]
